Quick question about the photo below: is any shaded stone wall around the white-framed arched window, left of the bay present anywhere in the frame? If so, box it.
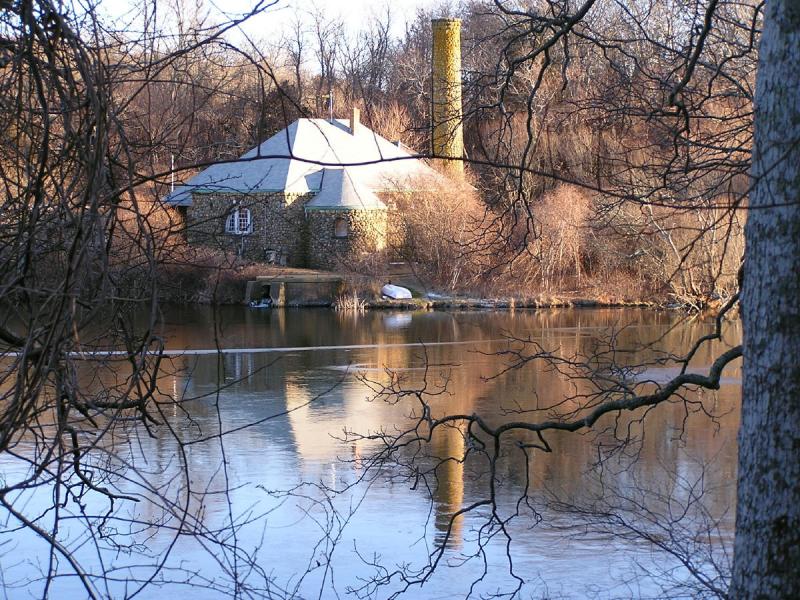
[186,192,311,266]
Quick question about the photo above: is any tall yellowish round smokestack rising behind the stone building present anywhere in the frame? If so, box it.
[431,19,464,174]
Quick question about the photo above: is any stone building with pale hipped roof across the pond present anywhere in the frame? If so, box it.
[166,110,440,269]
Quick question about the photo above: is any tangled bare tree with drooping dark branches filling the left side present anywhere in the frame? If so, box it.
[0,0,296,598]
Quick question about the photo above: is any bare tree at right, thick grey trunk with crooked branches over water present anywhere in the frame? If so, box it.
[348,0,800,597]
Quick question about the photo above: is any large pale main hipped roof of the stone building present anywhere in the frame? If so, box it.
[166,119,438,206]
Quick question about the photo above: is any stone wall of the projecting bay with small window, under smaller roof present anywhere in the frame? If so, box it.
[306,210,388,269]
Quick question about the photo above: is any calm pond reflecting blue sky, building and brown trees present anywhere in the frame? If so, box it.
[0,307,741,598]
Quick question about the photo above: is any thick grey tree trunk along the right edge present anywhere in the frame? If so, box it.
[730,0,800,598]
